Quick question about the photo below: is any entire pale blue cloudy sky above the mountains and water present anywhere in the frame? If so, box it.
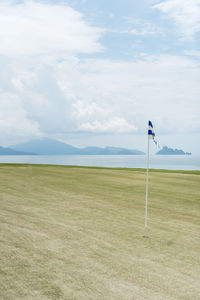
[0,0,200,154]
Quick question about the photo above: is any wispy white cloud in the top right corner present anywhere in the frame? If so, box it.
[153,0,200,39]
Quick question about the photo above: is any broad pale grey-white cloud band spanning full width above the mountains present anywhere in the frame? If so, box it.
[0,55,200,145]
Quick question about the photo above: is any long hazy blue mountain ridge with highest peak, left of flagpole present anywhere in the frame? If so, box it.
[12,138,144,155]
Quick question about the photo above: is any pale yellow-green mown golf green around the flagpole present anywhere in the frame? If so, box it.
[0,164,200,300]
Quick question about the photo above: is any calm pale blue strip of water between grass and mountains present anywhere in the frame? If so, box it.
[0,155,200,170]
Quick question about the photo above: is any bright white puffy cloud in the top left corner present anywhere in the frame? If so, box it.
[0,1,103,56]
